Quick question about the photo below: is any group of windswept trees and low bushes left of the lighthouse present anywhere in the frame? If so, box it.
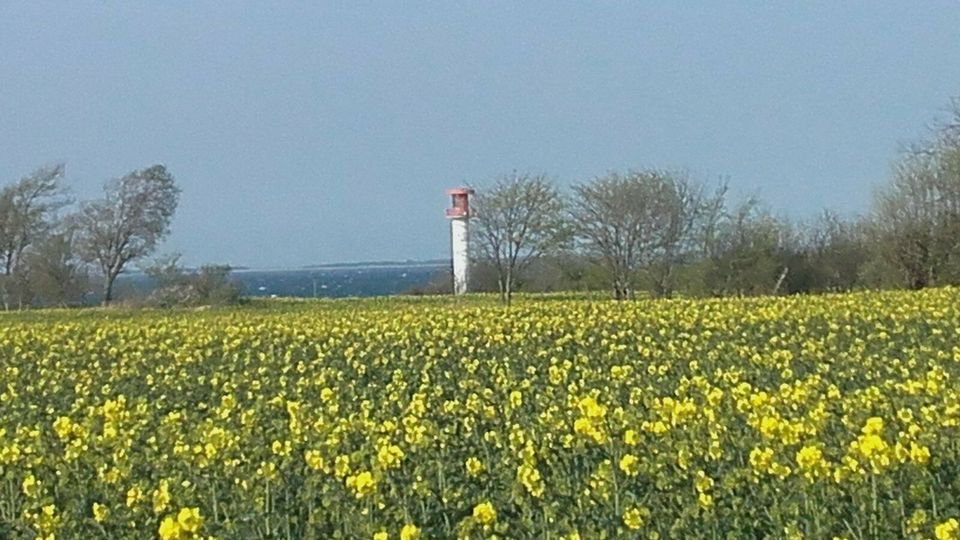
[0,164,239,310]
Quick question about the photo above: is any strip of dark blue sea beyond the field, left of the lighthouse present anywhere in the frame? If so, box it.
[117,261,450,298]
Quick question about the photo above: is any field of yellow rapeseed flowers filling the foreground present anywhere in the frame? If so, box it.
[0,289,960,540]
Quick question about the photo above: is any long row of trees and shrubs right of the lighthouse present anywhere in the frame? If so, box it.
[460,94,960,303]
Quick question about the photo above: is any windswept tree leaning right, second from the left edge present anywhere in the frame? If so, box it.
[76,165,180,305]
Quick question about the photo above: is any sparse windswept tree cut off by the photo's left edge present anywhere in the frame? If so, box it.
[0,163,69,309]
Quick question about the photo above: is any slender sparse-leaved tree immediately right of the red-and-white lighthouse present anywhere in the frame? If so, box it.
[473,173,568,305]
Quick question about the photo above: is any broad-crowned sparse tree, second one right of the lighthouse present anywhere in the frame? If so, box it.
[572,170,702,300]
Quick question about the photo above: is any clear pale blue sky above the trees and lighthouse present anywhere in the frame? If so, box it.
[0,0,960,268]
